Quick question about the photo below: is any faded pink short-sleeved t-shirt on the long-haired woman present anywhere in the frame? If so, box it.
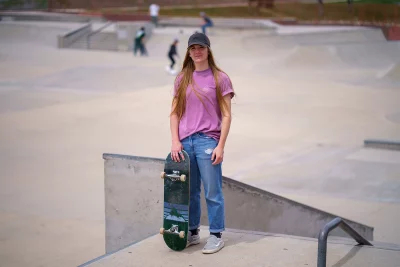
[174,69,233,140]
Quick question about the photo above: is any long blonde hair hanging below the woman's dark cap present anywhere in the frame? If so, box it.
[171,48,233,119]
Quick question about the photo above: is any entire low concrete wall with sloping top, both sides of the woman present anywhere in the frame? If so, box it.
[103,154,373,253]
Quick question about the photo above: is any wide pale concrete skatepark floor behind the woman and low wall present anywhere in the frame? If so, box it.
[0,17,400,266]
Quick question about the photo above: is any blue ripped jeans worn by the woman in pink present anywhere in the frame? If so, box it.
[181,133,225,233]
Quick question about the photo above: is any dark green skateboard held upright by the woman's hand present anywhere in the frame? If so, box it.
[160,151,190,251]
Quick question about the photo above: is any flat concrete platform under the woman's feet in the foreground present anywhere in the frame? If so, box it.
[83,227,400,267]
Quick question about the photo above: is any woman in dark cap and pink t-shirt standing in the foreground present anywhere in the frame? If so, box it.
[170,33,234,254]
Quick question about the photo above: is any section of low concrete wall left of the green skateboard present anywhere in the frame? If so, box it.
[103,154,164,253]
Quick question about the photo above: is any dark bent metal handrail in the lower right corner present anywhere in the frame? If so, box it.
[317,217,372,267]
